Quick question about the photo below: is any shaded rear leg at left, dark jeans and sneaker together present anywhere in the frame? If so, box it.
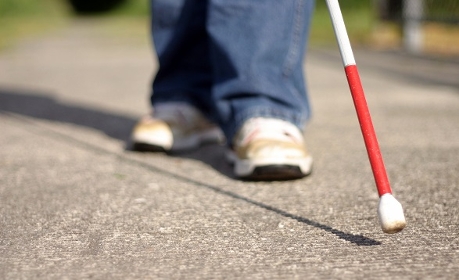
[131,0,223,152]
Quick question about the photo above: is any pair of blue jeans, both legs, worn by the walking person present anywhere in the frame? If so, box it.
[151,0,314,144]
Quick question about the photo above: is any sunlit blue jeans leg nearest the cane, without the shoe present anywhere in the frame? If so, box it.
[207,0,314,141]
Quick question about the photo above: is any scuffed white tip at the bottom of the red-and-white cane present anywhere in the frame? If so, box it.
[378,193,406,233]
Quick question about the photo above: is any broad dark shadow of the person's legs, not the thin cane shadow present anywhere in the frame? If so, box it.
[0,88,232,178]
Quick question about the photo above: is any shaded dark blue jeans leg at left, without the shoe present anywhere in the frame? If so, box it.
[151,0,214,117]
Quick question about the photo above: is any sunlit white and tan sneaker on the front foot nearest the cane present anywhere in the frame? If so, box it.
[229,118,312,180]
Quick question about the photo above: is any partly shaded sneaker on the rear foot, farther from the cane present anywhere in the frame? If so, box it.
[131,103,224,152]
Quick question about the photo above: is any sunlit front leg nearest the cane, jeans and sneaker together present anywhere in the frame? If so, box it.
[207,0,314,180]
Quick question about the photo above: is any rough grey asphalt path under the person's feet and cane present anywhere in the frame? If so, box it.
[0,18,459,279]
